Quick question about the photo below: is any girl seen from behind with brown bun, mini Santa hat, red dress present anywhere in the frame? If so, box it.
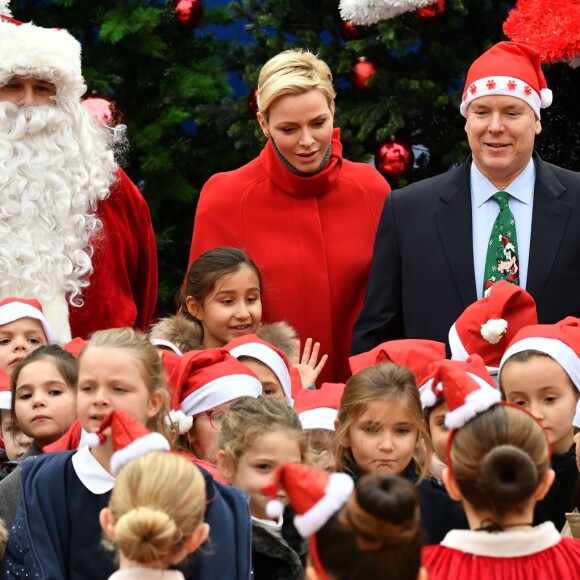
[423,376,580,580]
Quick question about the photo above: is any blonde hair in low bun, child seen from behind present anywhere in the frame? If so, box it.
[109,451,206,565]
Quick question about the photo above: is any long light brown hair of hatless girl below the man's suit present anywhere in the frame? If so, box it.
[336,362,433,480]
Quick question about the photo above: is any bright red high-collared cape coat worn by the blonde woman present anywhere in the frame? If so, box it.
[190,129,390,382]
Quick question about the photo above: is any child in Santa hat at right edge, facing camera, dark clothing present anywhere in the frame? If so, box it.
[499,316,580,529]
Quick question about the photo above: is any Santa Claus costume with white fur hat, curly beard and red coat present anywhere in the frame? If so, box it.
[0,2,157,342]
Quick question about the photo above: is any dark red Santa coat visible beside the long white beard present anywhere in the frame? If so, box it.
[69,169,157,338]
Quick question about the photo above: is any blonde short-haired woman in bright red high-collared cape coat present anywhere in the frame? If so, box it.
[190,50,390,382]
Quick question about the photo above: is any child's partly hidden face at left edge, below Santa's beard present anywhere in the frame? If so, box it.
[0,318,48,375]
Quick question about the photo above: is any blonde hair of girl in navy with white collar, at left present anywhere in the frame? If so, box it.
[78,328,174,442]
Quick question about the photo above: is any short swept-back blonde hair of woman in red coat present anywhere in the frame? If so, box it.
[258,50,336,117]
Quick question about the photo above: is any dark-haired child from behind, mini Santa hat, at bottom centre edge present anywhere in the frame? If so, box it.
[263,464,426,580]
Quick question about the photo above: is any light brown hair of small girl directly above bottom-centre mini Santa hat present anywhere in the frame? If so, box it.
[219,396,306,466]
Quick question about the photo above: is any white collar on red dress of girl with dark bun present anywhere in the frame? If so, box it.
[441,522,561,558]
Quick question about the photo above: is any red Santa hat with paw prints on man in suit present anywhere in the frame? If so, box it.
[459,41,552,119]
